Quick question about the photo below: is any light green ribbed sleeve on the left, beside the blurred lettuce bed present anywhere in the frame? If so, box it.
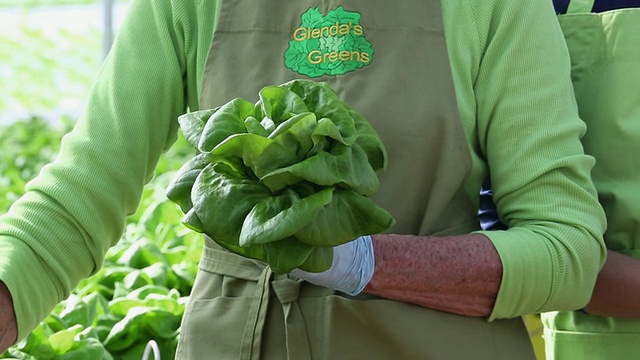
[0,0,194,339]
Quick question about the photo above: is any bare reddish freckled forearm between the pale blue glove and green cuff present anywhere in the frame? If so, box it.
[364,234,502,316]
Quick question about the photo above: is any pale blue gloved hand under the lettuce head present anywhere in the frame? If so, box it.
[291,236,375,296]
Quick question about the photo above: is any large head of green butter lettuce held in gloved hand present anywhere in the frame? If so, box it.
[167,80,394,273]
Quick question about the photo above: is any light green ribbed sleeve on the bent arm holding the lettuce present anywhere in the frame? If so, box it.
[443,0,606,319]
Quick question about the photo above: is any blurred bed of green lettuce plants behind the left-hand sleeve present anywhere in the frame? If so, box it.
[0,117,201,360]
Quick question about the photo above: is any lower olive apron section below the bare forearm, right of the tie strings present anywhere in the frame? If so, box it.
[300,296,534,360]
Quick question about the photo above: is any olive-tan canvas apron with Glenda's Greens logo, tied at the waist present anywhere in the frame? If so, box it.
[177,0,533,360]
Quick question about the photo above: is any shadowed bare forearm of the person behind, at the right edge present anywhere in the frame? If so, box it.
[584,250,640,318]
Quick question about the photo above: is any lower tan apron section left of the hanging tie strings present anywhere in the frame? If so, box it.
[176,243,263,359]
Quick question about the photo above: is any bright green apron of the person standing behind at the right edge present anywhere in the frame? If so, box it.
[543,0,640,360]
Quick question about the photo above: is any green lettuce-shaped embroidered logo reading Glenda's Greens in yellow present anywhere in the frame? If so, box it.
[284,6,373,78]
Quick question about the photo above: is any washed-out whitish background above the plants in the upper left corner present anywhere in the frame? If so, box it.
[0,0,127,124]
